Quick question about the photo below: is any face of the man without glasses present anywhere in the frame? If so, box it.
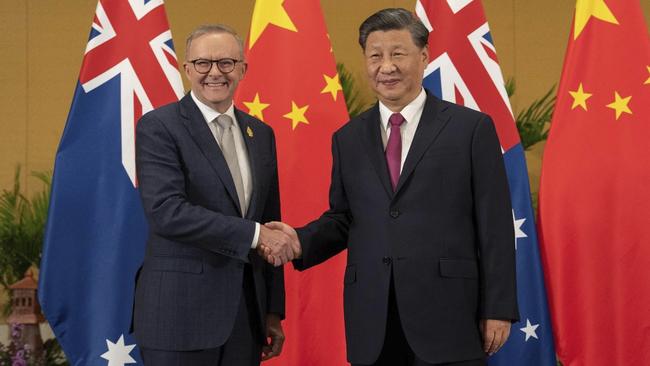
[364,29,429,112]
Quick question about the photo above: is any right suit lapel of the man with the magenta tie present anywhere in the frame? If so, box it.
[395,94,449,196]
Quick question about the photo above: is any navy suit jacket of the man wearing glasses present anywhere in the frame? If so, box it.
[133,94,284,350]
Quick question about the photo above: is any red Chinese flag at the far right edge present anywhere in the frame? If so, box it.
[539,0,650,366]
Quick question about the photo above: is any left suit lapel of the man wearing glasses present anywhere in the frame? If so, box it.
[180,93,241,215]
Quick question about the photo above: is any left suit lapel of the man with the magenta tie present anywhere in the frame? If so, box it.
[361,104,393,197]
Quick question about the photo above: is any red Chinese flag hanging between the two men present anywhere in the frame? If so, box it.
[236,0,348,366]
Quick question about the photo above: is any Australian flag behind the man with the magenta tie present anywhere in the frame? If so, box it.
[415,0,556,366]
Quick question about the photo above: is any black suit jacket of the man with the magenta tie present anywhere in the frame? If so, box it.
[294,91,519,364]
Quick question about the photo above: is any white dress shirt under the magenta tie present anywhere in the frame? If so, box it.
[379,88,427,173]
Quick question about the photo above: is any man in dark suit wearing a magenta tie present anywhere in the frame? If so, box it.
[268,9,519,366]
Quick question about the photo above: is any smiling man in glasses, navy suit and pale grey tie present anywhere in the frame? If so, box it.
[133,25,293,366]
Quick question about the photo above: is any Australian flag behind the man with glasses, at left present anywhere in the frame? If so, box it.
[39,0,183,366]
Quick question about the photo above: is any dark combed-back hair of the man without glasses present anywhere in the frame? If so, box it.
[359,8,429,50]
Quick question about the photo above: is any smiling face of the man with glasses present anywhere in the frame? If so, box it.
[183,32,246,113]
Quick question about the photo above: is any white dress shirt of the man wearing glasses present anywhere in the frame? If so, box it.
[190,91,260,248]
